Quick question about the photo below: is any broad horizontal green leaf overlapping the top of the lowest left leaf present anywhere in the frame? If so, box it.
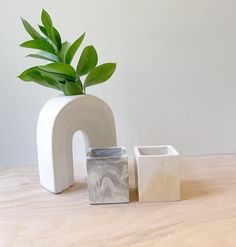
[39,63,75,80]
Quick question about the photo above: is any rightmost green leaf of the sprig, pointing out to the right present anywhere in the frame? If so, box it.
[84,63,116,87]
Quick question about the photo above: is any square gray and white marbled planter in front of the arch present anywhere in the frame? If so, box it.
[87,147,129,204]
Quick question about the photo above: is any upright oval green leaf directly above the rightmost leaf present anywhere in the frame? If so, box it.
[76,45,98,77]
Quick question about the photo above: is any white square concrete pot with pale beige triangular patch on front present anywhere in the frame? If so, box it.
[134,145,180,202]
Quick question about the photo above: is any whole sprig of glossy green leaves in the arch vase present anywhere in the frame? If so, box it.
[18,9,116,95]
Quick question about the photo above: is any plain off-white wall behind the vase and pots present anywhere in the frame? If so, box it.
[0,0,236,165]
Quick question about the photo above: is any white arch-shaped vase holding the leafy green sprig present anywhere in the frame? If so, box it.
[37,95,117,193]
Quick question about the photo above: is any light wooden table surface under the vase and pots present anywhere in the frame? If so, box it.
[0,155,236,247]
